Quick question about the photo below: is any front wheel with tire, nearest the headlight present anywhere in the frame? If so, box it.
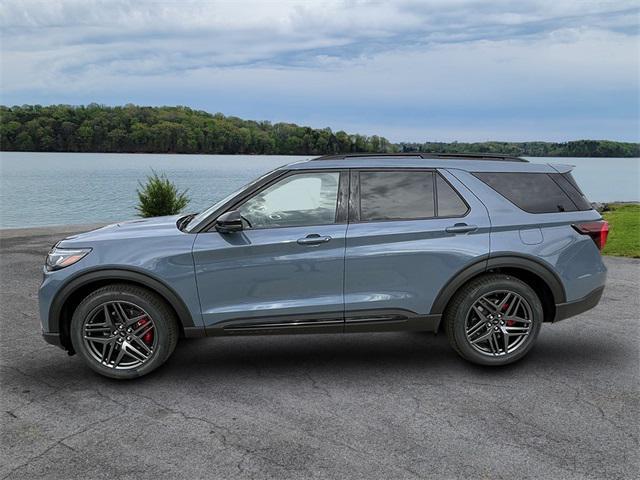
[70,284,179,380]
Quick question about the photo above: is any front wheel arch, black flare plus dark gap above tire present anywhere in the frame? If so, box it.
[49,268,194,354]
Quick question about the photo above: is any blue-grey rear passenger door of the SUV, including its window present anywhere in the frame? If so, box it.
[345,169,490,331]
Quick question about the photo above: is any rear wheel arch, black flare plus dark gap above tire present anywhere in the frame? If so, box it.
[430,254,566,322]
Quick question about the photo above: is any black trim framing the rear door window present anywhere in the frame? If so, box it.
[348,167,471,224]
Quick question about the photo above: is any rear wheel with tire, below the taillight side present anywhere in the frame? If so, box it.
[444,274,544,366]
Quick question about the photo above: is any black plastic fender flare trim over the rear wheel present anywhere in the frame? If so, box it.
[430,254,566,315]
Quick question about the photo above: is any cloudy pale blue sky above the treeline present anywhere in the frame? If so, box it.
[0,0,640,142]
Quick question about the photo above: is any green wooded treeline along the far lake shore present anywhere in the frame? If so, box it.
[0,104,640,157]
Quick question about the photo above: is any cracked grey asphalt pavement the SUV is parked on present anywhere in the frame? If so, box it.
[0,227,640,480]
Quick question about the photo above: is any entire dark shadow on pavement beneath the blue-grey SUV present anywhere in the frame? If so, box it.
[3,326,624,385]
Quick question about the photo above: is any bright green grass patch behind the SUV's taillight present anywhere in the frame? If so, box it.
[602,203,640,258]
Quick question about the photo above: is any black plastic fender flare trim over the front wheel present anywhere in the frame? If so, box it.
[49,268,195,333]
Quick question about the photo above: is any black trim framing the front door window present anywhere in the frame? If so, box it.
[203,168,349,232]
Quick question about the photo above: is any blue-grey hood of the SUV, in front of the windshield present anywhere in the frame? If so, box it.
[61,214,184,246]
